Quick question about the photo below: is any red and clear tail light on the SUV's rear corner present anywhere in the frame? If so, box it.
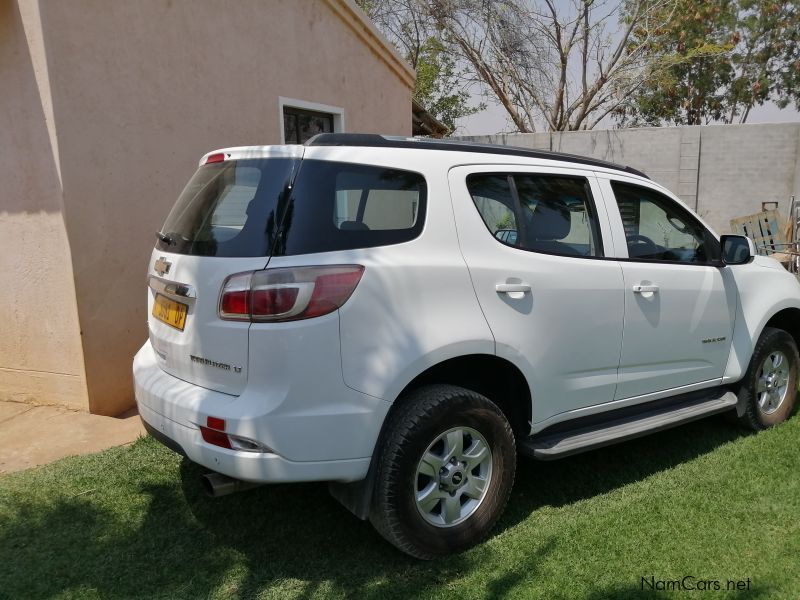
[219,265,364,322]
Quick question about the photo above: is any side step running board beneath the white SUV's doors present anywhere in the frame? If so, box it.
[519,388,737,460]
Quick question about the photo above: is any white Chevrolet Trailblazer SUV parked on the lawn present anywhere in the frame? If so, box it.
[133,134,800,558]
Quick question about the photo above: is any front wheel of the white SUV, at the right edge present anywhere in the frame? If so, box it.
[739,327,800,431]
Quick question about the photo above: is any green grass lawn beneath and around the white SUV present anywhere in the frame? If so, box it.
[0,416,800,600]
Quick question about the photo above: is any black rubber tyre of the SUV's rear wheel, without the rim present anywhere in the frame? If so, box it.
[370,385,517,560]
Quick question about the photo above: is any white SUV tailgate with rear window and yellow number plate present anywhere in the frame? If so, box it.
[148,147,302,394]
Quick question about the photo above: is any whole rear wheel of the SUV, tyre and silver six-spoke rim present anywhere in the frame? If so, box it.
[370,385,516,559]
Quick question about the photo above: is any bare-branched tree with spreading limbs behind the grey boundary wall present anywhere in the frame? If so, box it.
[418,0,671,132]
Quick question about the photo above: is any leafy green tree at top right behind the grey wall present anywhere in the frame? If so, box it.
[616,0,800,125]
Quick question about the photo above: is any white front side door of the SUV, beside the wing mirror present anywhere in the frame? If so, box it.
[599,176,737,399]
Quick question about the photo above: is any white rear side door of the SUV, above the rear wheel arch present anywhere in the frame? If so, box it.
[450,165,623,423]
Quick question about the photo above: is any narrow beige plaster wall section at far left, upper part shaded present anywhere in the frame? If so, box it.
[0,0,88,410]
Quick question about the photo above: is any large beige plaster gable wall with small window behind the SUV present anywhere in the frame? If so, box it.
[32,0,413,415]
